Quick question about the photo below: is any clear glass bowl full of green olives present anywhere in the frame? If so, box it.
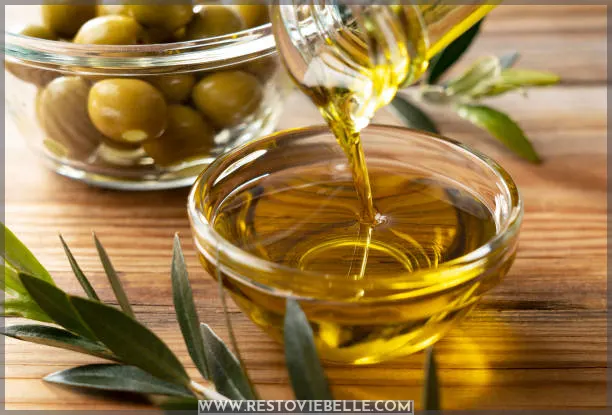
[4,0,291,190]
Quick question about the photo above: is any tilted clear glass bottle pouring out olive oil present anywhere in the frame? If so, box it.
[271,0,497,135]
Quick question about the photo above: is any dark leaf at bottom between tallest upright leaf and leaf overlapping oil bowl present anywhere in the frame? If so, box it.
[200,323,255,400]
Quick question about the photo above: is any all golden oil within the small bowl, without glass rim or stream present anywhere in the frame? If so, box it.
[208,161,496,364]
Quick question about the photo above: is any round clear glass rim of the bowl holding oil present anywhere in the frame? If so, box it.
[187,124,524,302]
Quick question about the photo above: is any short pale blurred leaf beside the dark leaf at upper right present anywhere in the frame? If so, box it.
[446,56,501,96]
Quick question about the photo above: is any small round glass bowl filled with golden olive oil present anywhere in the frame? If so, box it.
[189,126,521,364]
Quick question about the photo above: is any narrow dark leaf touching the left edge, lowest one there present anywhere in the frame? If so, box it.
[0,324,117,360]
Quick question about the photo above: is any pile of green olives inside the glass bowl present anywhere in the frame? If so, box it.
[6,2,276,166]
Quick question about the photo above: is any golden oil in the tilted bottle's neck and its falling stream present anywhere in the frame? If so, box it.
[272,5,494,278]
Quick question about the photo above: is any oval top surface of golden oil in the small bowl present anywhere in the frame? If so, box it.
[214,163,496,280]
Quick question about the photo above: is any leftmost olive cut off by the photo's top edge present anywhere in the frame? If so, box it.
[42,1,96,38]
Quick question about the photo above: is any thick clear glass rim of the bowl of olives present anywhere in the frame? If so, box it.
[4,23,276,73]
